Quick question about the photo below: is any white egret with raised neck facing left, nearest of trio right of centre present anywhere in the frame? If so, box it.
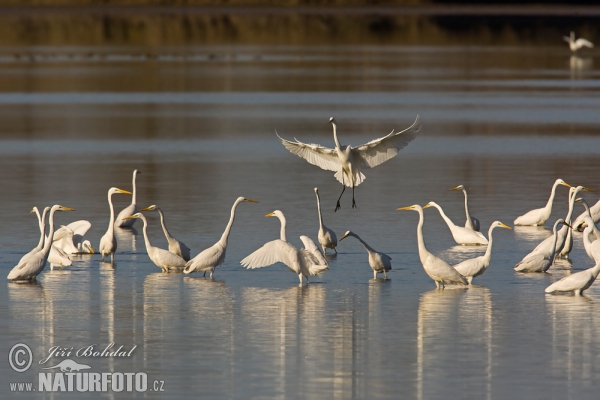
[398,204,468,289]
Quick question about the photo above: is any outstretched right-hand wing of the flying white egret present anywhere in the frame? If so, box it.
[352,115,421,168]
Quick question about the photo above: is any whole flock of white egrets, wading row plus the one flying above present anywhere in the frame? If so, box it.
[8,108,600,295]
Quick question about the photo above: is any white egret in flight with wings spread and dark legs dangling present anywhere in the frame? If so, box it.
[277,116,421,211]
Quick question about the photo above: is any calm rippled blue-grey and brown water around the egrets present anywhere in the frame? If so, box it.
[0,42,600,399]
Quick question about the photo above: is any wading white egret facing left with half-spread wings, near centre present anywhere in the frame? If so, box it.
[240,210,329,284]
